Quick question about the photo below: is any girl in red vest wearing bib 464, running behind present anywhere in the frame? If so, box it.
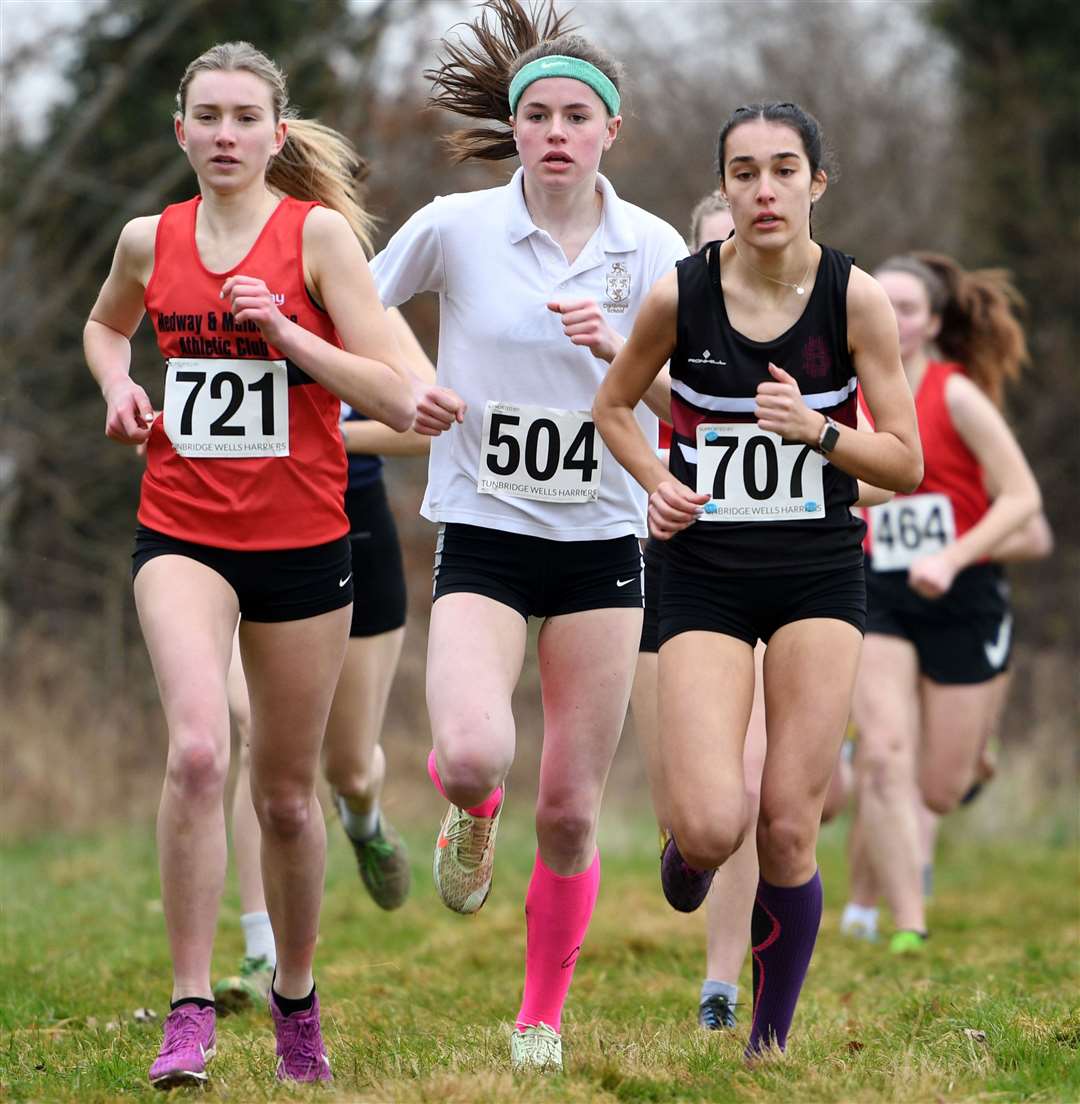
[846,254,1045,954]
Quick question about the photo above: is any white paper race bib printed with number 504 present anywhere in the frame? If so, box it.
[476,401,604,502]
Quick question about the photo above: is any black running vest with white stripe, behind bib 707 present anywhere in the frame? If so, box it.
[666,242,866,574]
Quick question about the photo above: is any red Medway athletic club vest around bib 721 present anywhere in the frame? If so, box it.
[138,195,349,551]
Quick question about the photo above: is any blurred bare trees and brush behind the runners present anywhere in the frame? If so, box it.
[0,0,1080,830]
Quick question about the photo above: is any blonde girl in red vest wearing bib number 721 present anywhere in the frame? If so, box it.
[84,42,414,1087]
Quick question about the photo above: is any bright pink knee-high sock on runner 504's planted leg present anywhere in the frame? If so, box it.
[517,851,600,1031]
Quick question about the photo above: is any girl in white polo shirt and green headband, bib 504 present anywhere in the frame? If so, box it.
[372,0,686,1066]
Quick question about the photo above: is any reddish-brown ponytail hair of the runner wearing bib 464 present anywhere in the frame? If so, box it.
[875,250,1030,406]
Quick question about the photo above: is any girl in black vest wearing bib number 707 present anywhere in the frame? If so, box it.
[593,104,922,1055]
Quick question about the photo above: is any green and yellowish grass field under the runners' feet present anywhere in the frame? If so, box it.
[0,799,1080,1104]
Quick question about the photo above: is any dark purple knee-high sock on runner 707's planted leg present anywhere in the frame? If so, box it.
[747,870,822,1058]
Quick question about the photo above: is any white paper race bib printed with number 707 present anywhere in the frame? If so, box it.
[697,422,825,521]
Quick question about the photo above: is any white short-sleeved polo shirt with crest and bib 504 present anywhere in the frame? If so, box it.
[371,169,687,541]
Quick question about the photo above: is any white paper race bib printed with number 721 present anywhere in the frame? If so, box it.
[165,358,288,459]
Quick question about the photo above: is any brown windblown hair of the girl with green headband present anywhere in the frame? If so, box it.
[424,0,623,163]
